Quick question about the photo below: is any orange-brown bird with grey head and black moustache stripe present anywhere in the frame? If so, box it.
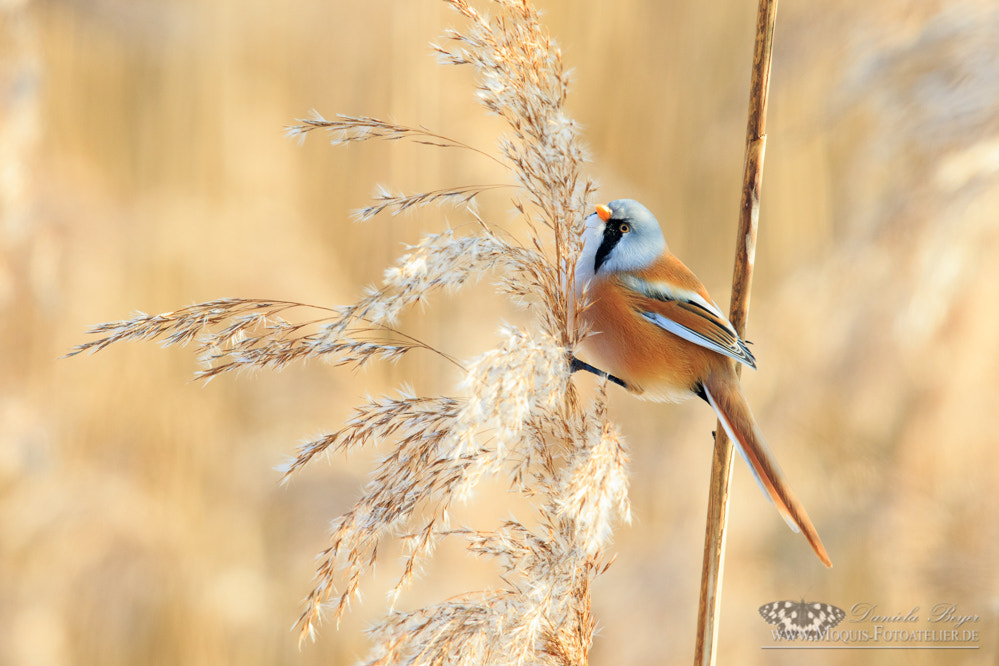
[573,199,832,566]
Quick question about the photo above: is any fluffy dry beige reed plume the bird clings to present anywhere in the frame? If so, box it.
[70,0,629,664]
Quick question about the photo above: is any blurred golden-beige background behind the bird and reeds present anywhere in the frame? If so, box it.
[0,0,999,666]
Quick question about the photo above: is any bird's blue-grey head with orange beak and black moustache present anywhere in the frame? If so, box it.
[577,199,666,280]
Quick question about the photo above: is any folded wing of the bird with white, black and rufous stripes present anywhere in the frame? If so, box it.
[621,274,756,368]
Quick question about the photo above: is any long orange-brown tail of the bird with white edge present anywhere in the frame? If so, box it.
[704,367,832,567]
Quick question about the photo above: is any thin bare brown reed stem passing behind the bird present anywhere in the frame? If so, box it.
[694,0,777,666]
